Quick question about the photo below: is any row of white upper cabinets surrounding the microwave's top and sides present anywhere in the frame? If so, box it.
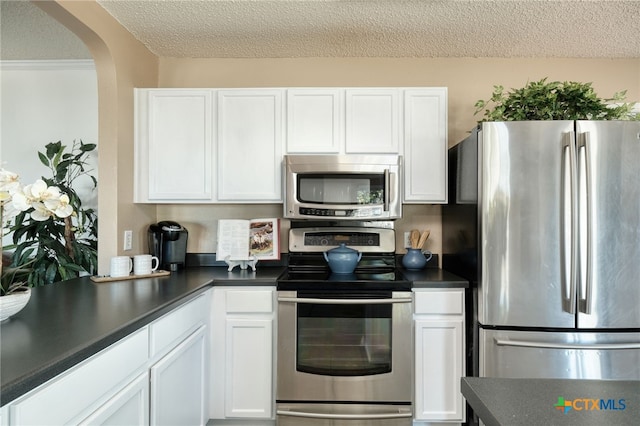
[134,87,447,204]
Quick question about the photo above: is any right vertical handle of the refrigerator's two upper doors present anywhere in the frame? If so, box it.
[577,132,593,314]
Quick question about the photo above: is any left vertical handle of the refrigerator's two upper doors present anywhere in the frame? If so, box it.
[561,132,578,314]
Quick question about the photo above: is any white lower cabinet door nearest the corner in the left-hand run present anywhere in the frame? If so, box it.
[150,326,208,425]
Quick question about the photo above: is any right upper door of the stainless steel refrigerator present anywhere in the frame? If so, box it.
[576,121,640,328]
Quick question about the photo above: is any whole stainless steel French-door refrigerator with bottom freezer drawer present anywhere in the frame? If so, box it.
[442,121,640,379]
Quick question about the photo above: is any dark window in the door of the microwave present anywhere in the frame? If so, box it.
[297,173,384,205]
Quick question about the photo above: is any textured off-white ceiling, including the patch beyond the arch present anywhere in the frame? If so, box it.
[0,0,640,59]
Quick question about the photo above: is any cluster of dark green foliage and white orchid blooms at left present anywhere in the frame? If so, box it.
[0,141,98,295]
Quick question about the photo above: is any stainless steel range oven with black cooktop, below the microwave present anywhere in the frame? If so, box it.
[277,224,413,426]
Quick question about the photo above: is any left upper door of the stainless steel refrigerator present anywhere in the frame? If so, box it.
[478,121,575,328]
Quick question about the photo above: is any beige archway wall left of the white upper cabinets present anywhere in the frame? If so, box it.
[34,1,158,274]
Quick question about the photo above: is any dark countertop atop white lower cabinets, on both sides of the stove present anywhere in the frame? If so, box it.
[0,265,467,405]
